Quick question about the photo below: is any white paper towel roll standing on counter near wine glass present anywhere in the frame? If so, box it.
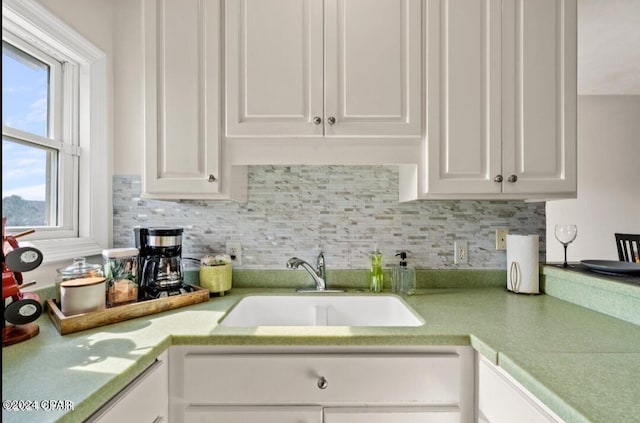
[507,235,540,294]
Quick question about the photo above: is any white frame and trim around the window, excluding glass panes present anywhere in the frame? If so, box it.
[2,0,112,263]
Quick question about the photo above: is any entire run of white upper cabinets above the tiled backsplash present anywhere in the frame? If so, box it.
[143,0,577,200]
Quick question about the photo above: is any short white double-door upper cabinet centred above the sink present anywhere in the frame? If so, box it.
[225,0,423,138]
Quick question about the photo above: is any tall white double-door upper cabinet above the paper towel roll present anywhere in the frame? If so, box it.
[422,0,576,198]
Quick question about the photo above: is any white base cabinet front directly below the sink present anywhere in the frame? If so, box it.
[169,346,474,423]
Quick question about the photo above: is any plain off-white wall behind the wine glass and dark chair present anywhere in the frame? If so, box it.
[546,95,640,262]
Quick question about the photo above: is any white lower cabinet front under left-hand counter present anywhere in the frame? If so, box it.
[87,351,169,423]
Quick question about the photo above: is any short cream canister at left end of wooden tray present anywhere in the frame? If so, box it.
[60,277,105,316]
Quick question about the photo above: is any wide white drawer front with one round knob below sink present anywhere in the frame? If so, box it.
[182,353,461,405]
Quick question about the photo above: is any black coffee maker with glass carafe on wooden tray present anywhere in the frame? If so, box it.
[134,227,192,300]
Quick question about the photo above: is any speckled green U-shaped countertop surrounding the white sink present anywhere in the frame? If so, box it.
[2,270,640,422]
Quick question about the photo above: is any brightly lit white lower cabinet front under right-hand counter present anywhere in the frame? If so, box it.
[478,356,563,423]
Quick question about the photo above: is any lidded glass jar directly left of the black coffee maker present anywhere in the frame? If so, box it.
[102,248,139,307]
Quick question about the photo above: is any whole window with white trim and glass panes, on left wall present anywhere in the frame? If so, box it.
[2,0,111,262]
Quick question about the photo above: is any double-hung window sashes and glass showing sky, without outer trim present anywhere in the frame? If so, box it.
[2,38,65,230]
